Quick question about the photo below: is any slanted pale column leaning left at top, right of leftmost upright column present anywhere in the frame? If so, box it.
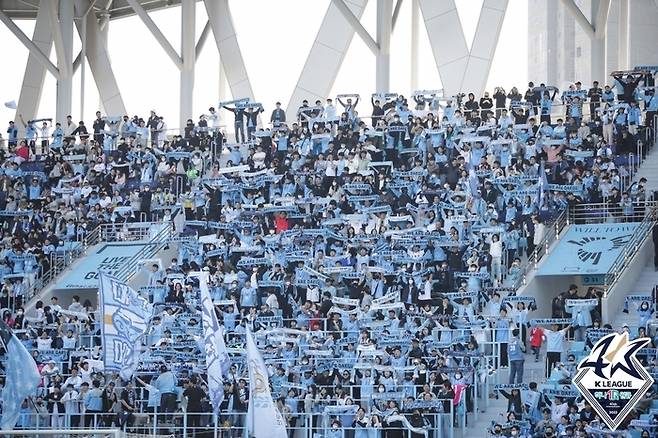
[75,0,126,116]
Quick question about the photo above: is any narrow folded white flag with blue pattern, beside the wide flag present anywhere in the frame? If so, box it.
[190,272,231,414]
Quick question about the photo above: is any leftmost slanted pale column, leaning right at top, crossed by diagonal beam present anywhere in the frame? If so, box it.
[14,4,53,126]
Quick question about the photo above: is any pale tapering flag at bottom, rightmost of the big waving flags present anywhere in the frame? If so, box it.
[246,326,288,438]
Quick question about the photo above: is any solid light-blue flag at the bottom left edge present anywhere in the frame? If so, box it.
[0,320,41,430]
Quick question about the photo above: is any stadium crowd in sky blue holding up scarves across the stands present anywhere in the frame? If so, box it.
[0,72,658,438]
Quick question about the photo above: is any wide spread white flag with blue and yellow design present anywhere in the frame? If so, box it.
[99,272,153,380]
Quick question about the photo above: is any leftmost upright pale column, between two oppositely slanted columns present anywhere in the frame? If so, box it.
[55,0,73,124]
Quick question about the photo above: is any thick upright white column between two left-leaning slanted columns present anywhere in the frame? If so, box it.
[178,0,196,129]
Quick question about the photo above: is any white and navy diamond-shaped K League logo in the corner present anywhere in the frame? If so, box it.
[573,333,653,430]
